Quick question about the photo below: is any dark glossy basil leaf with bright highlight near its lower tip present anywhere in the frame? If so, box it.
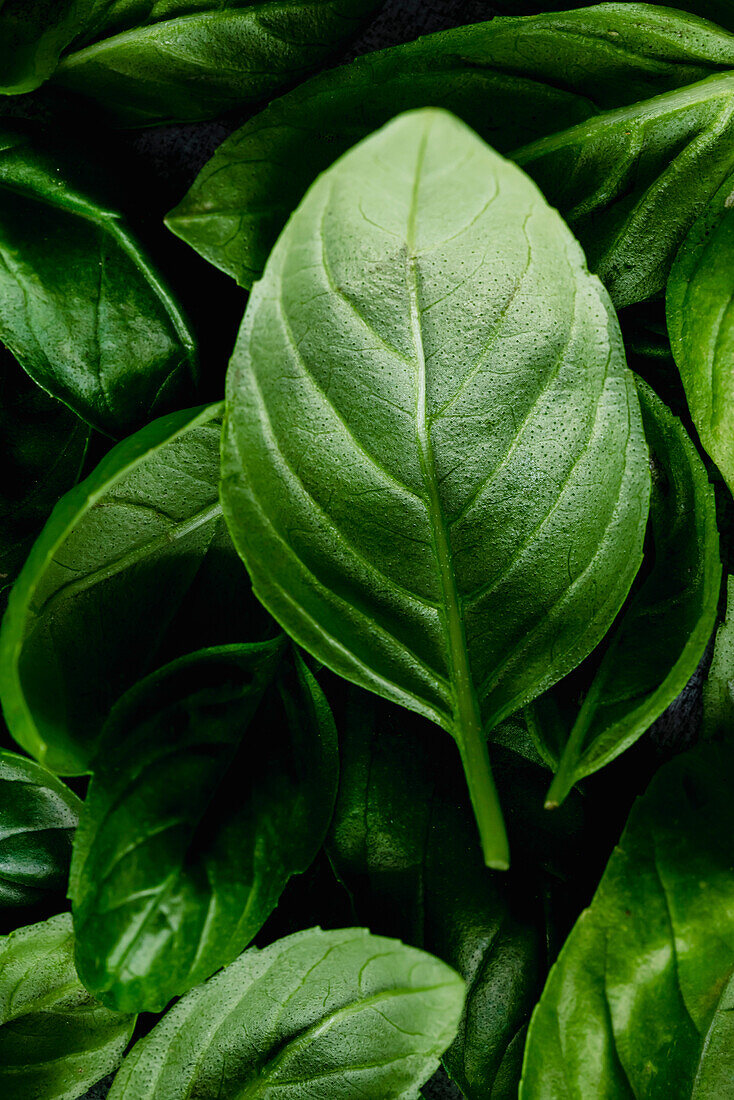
[69,638,338,1012]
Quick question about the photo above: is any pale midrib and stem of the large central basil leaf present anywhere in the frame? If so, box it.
[406,123,510,869]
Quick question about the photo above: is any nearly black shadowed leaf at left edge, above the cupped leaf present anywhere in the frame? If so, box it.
[0,348,89,591]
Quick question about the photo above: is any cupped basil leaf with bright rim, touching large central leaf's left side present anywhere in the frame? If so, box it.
[0,405,271,774]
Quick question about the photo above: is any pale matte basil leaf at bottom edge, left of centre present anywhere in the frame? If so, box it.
[110,928,463,1100]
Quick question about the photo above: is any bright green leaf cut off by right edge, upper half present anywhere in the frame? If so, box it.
[666,175,734,490]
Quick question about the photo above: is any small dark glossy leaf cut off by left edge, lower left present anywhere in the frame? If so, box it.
[0,750,81,909]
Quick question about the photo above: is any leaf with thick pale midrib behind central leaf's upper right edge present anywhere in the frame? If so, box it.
[514,73,734,308]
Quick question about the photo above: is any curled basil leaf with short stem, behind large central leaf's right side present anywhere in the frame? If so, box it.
[527,383,721,806]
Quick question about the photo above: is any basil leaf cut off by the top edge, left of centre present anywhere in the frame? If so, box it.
[53,0,379,125]
